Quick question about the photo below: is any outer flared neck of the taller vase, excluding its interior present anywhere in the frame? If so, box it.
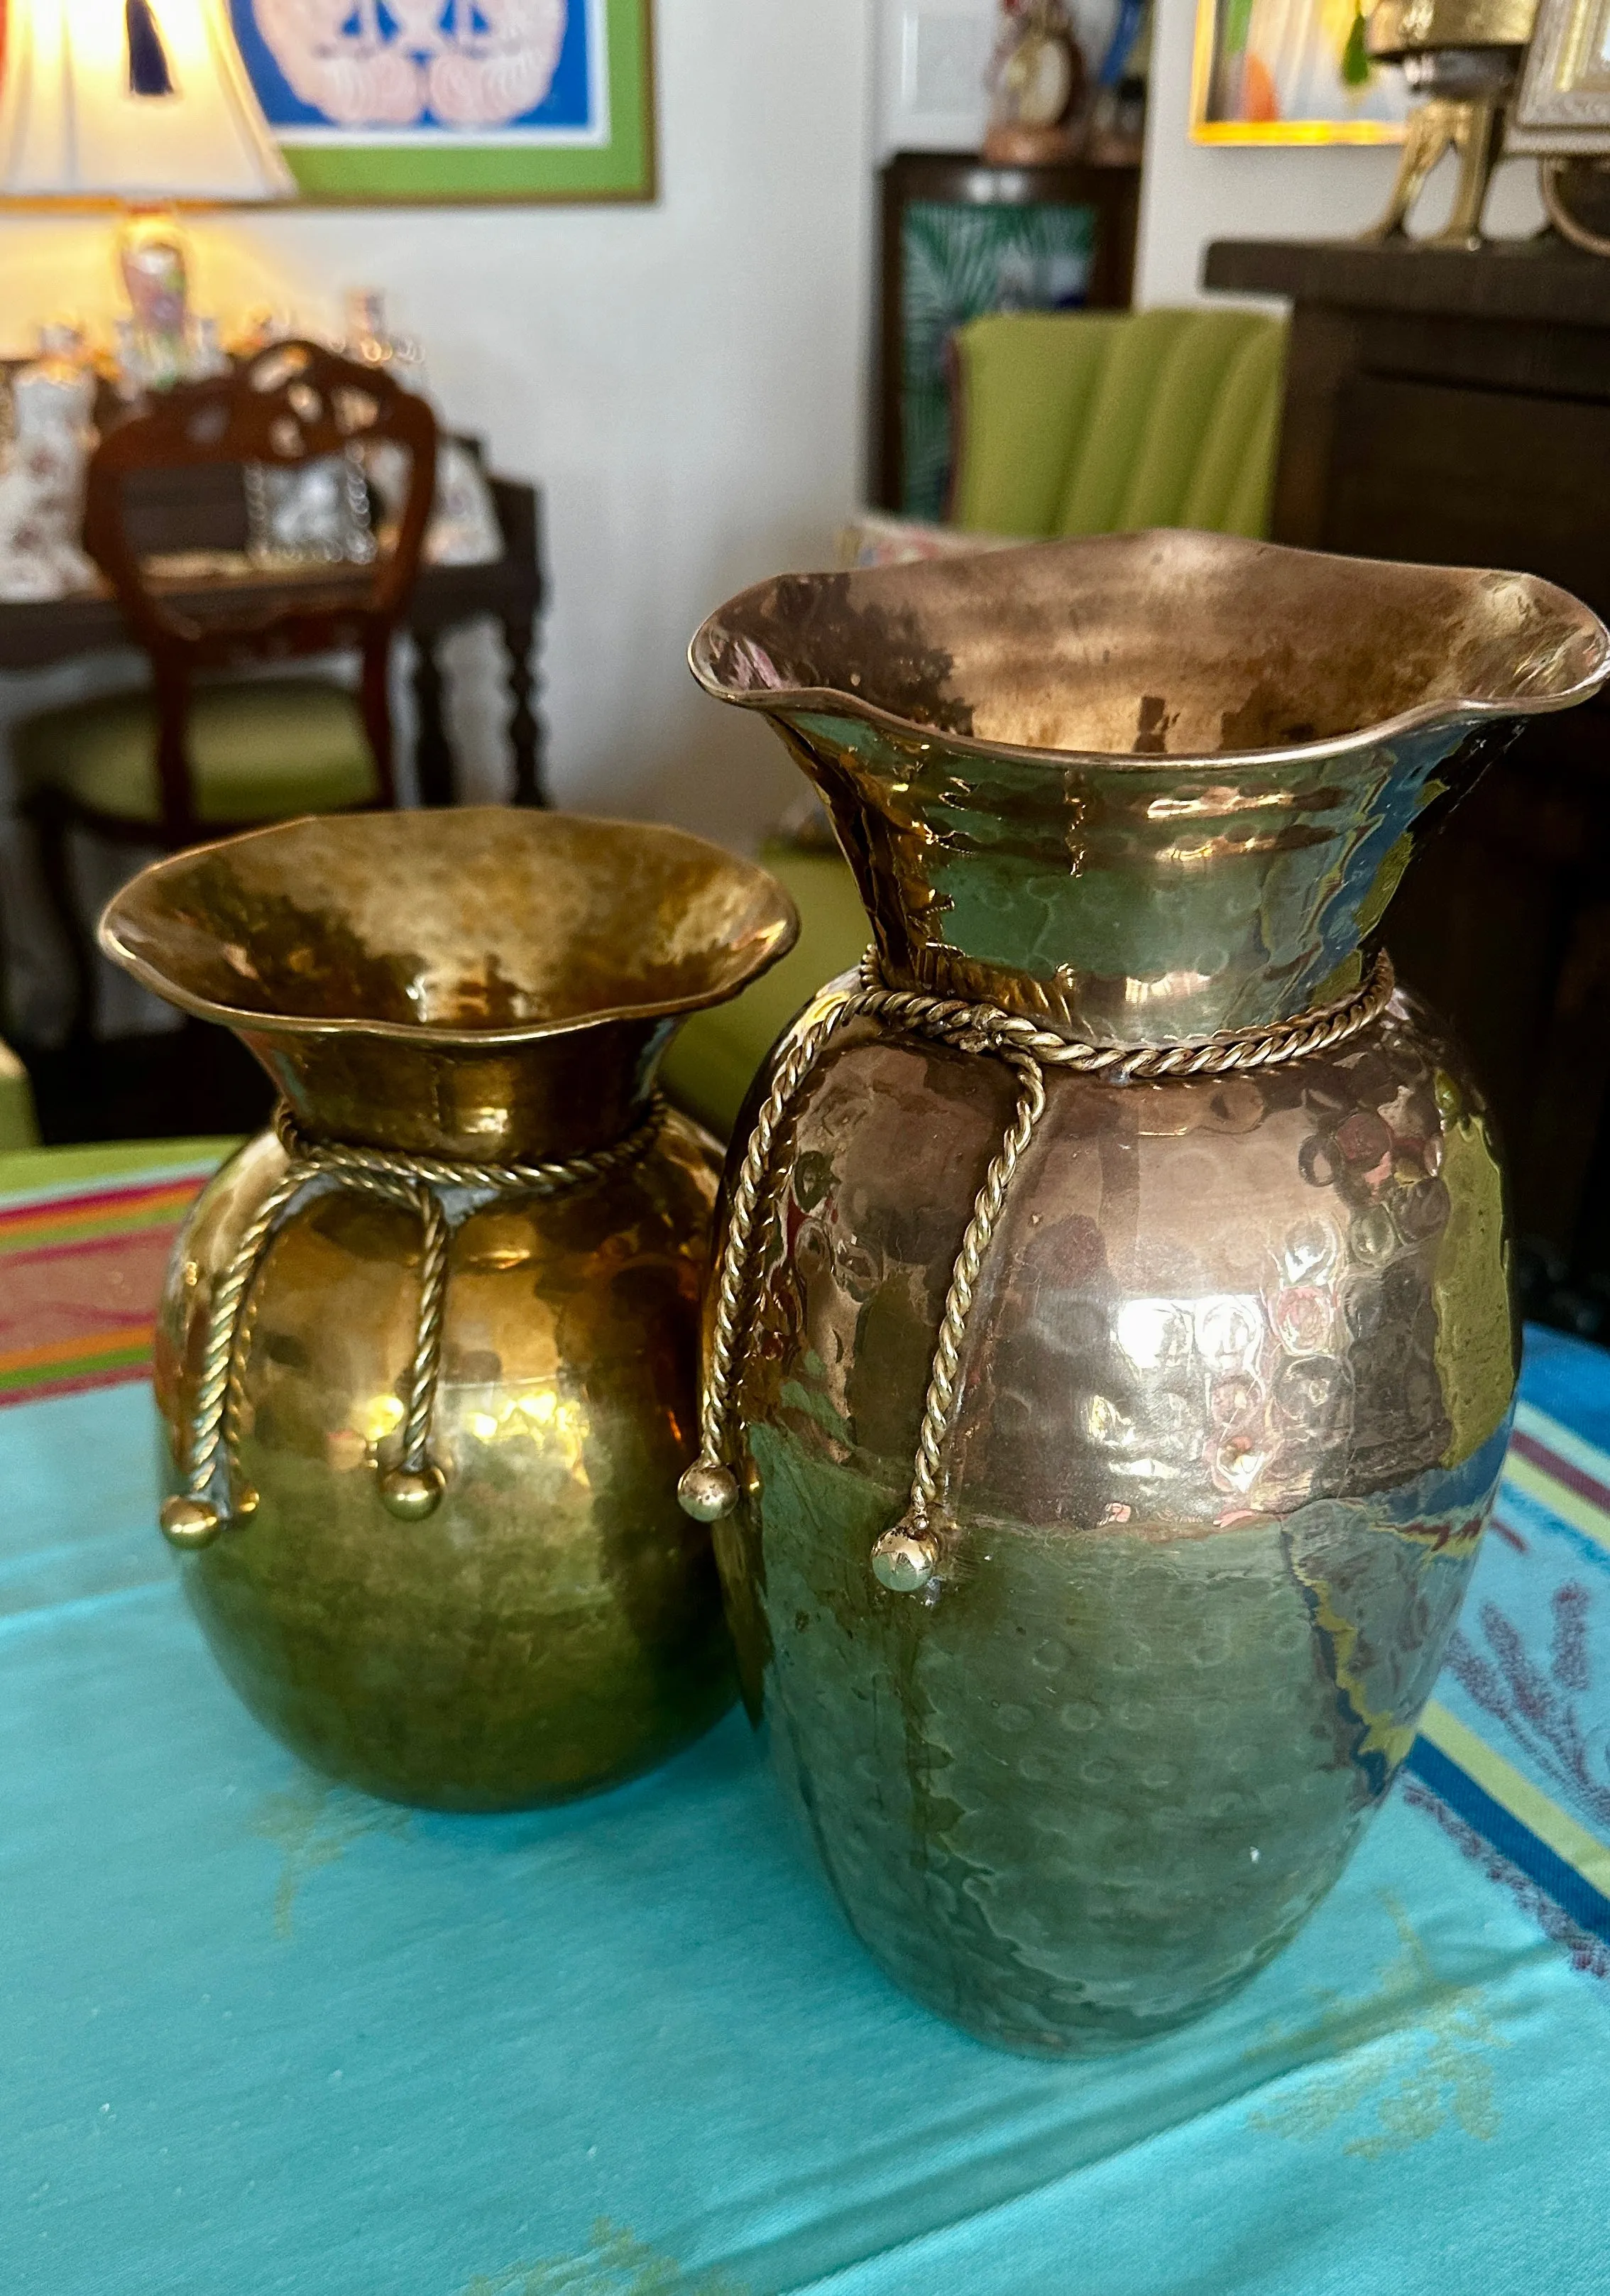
[779,712,1502,1044]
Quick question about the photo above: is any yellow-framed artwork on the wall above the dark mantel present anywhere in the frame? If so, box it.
[1190,0,1411,145]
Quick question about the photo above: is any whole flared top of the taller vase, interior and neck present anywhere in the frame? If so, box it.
[691,532,1610,1044]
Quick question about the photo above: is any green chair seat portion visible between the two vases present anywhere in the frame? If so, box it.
[662,843,872,1139]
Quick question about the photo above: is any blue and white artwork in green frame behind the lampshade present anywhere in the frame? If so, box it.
[230,0,655,202]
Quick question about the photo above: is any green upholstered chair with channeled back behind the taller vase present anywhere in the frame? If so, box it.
[666,310,1286,1132]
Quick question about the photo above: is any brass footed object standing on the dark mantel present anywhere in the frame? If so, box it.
[1364,0,1536,248]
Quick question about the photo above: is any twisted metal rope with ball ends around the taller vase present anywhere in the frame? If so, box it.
[677,949,1396,1593]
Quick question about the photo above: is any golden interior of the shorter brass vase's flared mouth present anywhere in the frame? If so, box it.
[106,806,794,1040]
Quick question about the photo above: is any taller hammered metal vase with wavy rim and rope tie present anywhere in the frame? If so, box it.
[682,532,1610,2052]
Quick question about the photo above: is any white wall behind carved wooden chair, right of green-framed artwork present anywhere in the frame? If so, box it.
[0,0,870,863]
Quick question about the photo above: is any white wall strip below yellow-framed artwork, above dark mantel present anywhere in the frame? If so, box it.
[1134,0,1543,305]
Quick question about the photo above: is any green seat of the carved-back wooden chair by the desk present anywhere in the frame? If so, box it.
[11,677,379,826]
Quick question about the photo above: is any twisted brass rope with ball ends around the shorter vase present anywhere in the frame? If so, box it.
[160,1093,666,1548]
